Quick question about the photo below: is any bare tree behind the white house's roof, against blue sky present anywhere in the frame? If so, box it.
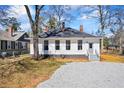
[44,5,74,28]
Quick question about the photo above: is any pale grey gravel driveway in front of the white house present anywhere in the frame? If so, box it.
[37,62,124,88]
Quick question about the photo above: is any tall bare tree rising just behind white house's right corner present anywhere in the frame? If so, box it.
[81,5,109,52]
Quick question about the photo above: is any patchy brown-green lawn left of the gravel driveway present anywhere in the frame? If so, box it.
[0,56,64,88]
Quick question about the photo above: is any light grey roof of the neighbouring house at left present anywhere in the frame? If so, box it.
[0,31,25,41]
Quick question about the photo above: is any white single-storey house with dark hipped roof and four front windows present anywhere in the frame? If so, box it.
[30,25,101,60]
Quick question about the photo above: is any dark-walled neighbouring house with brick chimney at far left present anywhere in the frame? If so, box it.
[0,27,29,55]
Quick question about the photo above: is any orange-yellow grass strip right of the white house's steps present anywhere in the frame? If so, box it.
[101,54,124,63]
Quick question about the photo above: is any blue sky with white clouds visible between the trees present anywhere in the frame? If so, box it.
[0,5,123,35]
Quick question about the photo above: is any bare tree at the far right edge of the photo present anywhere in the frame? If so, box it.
[109,6,124,54]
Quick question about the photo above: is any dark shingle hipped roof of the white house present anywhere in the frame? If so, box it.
[39,28,96,38]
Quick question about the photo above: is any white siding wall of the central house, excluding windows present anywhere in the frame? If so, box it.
[30,38,100,55]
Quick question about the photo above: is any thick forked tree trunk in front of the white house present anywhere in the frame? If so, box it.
[25,5,44,60]
